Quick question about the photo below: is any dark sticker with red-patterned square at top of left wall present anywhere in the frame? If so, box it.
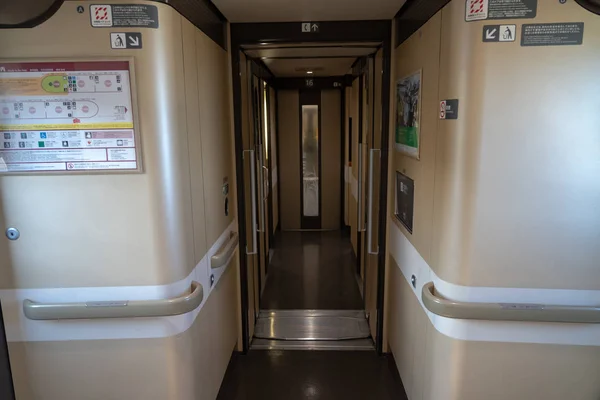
[90,4,158,28]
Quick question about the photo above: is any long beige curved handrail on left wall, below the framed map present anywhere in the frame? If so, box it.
[23,281,204,320]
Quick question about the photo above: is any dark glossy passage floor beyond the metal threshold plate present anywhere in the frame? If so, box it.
[261,231,364,310]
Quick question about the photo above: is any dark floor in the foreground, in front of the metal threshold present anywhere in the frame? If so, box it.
[217,350,407,400]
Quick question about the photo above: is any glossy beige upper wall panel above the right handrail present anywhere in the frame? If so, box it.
[432,0,600,290]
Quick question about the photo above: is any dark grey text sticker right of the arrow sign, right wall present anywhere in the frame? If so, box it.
[521,22,583,46]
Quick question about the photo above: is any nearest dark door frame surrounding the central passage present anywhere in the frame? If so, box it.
[230,20,392,354]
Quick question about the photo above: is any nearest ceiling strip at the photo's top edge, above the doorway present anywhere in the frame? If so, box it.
[212,0,406,22]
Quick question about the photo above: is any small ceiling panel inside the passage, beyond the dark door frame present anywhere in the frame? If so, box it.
[263,57,356,78]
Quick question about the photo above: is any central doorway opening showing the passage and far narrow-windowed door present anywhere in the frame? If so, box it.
[232,23,389,350]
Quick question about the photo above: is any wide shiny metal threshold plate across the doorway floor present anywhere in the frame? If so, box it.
[254,310,370,341]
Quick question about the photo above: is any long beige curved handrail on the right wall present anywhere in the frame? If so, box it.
[421,282,600,324]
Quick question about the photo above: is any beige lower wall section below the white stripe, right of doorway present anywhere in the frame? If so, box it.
[388,258,600,400]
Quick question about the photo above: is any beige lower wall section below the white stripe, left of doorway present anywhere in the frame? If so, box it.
[9,257,239,400]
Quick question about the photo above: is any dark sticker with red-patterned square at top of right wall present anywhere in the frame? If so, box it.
[465,0,538,21]
